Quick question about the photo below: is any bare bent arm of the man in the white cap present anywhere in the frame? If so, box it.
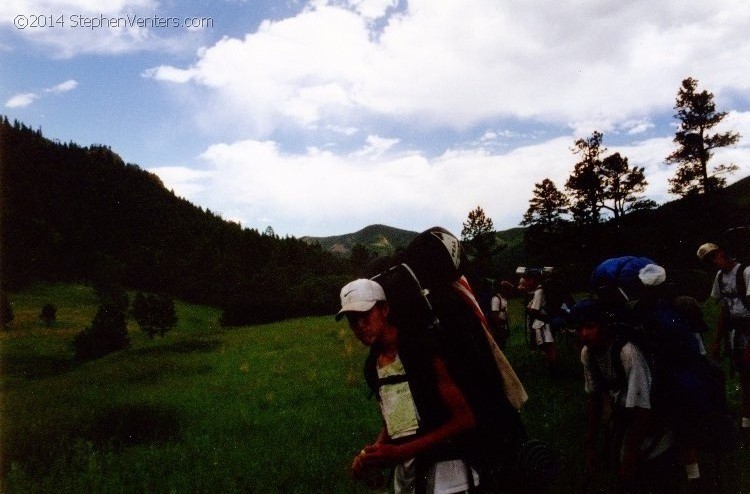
[362,358,476,465]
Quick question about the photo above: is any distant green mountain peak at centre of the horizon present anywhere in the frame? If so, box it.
[300,225,418,257]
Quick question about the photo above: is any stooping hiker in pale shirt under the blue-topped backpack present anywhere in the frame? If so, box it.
[571,299,680,493]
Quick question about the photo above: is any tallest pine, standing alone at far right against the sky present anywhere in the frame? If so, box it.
[666,77,740,196]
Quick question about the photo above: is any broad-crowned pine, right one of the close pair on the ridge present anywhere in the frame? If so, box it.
[599,153,656,221]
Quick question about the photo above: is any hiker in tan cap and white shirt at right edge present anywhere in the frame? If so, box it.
[698,243,750,444]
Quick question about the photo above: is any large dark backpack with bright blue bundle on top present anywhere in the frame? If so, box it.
[592,257,737,452]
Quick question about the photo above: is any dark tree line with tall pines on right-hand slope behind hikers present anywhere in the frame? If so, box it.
[462,77,748,288]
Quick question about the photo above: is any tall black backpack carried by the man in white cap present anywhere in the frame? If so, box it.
[365,228,557,492]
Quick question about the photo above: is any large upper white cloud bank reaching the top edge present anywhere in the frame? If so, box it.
[147,0,750,137]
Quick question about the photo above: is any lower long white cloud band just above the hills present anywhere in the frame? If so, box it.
[151,117,750,236]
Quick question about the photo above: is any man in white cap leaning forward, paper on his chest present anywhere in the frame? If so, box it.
[336,279,479,494]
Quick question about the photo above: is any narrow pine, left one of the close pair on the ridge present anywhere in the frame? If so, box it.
[565,131,606,224]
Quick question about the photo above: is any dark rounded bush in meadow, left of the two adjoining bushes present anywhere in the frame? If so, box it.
[73,304,130,360]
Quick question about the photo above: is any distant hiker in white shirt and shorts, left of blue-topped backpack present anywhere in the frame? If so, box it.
[518,269,559,377]
